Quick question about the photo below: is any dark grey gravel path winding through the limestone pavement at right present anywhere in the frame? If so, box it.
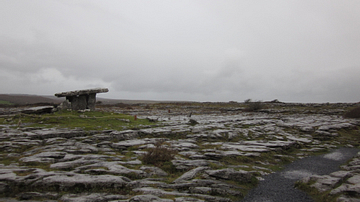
[243,148,359,202]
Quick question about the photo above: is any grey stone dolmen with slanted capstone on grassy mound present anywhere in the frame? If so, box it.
[55,88,109,111]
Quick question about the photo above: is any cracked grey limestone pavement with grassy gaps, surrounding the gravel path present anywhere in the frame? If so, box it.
[0,104,360,201]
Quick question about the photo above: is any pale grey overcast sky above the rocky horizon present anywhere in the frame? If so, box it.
[0,0,360,102]
